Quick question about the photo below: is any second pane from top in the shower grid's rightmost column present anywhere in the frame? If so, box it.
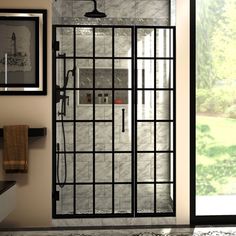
[156,60,174,88]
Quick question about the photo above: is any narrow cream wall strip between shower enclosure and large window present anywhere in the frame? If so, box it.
[176,0,190,224]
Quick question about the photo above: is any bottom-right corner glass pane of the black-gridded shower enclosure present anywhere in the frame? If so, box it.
[156,184,173,212]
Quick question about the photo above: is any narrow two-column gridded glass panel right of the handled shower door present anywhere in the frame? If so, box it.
[135,27,175,215]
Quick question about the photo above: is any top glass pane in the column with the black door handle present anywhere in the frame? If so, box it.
[115,28,132,57]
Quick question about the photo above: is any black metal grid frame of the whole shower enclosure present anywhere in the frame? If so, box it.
[52,25,176,218]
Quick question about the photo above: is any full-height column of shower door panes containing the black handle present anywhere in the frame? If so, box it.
[113,27,134,214]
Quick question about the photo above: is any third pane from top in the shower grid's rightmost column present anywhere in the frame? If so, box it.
[156,91,173,120]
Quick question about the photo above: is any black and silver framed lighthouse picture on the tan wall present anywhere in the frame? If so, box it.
[0,9,47,95]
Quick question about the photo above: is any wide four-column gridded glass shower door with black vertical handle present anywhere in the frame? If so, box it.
[56,26,133,217]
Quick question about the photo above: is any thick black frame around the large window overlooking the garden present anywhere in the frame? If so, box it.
[190,0,236,225]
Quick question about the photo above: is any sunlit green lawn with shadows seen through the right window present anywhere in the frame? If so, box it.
[196,116,236,195]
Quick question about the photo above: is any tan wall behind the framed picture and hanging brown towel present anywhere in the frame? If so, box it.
[0,0,52,227]
